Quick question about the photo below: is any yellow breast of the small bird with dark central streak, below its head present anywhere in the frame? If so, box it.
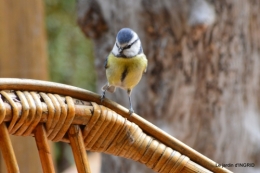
[106,53,147,89]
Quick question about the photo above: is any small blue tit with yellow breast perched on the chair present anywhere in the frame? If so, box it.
[101,28,148,114]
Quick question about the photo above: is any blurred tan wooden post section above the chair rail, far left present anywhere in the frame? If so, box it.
[0,0,48,80]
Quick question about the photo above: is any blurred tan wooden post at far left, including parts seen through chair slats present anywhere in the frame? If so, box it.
[0,0,48,173]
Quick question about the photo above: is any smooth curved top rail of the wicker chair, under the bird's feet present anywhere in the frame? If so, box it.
[0,78,230,172]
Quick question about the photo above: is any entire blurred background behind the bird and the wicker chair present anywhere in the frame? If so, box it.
[0,0,260,173]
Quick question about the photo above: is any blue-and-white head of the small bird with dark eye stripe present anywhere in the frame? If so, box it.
[112,28,142,58]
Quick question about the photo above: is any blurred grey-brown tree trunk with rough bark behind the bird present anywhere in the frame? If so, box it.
[78,0,260,173]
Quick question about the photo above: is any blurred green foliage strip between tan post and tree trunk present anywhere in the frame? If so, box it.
[45,0,96,91]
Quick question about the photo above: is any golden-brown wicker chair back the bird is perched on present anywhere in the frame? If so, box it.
[0,78,230,173]
